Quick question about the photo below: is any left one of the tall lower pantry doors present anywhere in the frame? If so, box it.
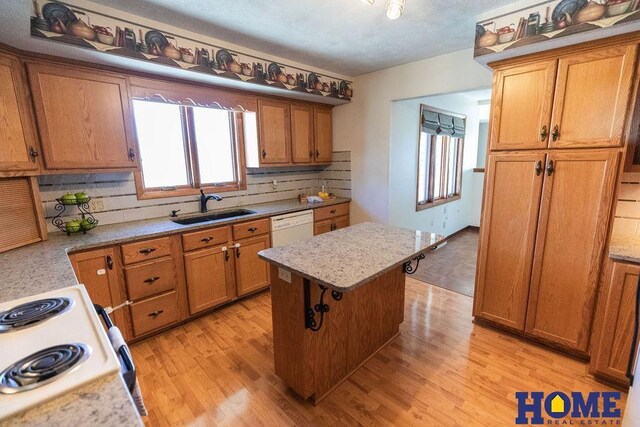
[474,153,544,330]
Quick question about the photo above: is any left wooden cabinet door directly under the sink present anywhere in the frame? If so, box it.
[184,246,236,314]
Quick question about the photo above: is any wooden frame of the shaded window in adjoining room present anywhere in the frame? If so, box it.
[416,104,467,212]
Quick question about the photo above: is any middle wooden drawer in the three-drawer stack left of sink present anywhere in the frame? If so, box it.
[124,258,176,301]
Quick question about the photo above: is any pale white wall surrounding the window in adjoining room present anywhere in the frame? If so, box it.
[389,93,482,236]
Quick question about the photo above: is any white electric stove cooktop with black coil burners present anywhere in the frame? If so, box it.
[0,285,120,424]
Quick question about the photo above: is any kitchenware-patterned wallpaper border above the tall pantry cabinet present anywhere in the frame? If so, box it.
[473,0,640,58]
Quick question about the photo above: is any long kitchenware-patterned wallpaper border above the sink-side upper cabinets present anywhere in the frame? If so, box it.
[31,1,353,101]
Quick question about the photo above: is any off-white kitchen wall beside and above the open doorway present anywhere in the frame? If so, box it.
[333,49,491,223]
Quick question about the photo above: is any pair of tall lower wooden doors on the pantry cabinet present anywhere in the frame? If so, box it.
[474,149,620,356]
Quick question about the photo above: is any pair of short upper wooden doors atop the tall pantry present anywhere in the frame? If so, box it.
[489,44,637,150]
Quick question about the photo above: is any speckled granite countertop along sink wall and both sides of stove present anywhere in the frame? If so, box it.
[0,198,351,426]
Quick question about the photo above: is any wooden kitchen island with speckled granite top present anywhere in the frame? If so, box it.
[259,222,445,404]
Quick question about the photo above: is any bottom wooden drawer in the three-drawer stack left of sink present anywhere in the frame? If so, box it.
[131,291,178,337]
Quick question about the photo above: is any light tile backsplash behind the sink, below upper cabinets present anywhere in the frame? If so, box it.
[38,151,351,232]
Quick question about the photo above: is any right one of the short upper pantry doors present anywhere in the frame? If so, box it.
[549,45,637,148]
